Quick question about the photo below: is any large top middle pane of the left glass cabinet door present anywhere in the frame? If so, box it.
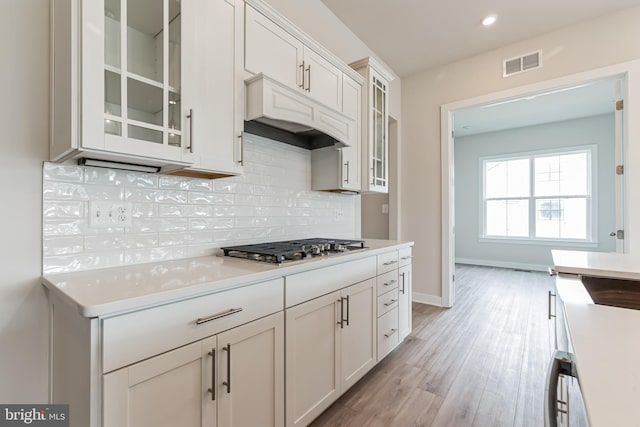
[127,0,164,83]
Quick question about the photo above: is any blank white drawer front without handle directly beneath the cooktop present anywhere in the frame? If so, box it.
[285,256,376,307]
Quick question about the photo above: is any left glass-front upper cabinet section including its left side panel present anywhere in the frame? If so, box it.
[50,0,188,168]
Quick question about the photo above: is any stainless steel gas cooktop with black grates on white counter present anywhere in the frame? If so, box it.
[221,238,364,264]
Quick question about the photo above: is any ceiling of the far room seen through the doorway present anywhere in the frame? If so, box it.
[454,79,617,138]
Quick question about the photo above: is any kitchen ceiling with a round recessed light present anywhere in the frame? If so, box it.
[321,0,640,77]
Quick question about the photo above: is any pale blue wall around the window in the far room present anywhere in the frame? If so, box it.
[454,115,616,270]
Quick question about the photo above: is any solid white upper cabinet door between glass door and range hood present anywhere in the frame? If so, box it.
[180,0,244,178]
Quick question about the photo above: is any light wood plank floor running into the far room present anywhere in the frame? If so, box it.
[312,265,564,427]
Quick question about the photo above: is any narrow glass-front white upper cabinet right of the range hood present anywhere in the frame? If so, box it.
[351,58,393,193]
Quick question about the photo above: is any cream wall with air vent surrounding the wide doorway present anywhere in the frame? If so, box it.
[400,7,640,299]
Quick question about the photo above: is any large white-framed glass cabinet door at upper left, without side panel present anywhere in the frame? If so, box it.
[103,0,186,160]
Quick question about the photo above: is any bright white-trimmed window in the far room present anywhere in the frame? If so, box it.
[481,146,596,242]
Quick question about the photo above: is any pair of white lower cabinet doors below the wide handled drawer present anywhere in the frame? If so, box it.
[103,312,284,427]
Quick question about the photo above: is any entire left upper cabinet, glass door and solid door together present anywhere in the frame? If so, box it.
[50,0,244,177]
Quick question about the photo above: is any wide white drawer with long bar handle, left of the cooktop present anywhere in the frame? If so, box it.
[102,278,284,372]
